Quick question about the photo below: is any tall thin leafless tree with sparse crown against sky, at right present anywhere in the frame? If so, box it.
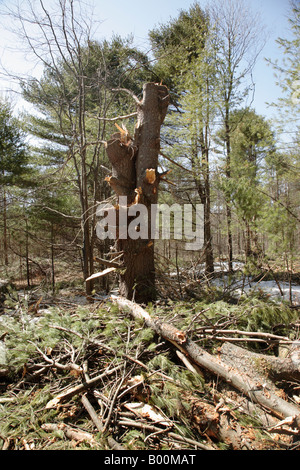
[209,0,264,271]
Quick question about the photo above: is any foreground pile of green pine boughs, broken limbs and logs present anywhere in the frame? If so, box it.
[0,290,300,450]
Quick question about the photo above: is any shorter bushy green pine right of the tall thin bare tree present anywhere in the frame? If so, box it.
[221,108,276,261]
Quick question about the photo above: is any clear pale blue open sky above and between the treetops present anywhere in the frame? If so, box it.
[0,0,296,117]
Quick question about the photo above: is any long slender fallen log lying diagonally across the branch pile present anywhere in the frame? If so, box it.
[111,296,300,419]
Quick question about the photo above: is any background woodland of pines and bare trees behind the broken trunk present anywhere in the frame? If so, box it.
[0,2,299,290]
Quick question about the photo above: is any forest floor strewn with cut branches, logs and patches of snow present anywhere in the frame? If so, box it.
[0,260,300,451]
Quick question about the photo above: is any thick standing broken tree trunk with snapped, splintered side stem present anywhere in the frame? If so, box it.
[106,83,169,302]
